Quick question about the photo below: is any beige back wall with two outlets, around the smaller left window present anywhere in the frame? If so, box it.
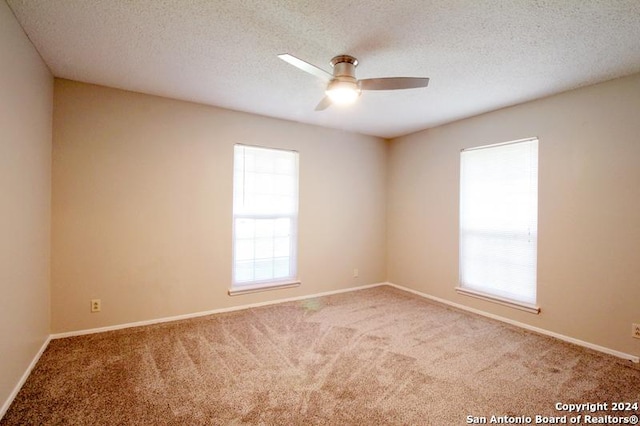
[52,79,387,332]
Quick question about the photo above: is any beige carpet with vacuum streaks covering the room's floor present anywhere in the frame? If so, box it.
[0,286,640,425]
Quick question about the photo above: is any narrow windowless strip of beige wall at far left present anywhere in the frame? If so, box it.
[0,1,53,417]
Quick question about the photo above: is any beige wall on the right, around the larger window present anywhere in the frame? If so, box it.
[387,75,640,356]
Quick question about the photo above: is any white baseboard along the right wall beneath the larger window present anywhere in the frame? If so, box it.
[385,283,640,364]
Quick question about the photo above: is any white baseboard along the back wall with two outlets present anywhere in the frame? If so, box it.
[51,283,387,339]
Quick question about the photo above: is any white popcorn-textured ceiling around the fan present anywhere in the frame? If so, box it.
[7,0,640,138]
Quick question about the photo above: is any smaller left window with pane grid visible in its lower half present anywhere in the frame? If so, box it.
[229,145,300,294]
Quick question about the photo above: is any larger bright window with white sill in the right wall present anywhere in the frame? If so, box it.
[457,139,539,313]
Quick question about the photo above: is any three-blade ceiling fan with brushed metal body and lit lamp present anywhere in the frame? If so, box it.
[278,53,429,111]
